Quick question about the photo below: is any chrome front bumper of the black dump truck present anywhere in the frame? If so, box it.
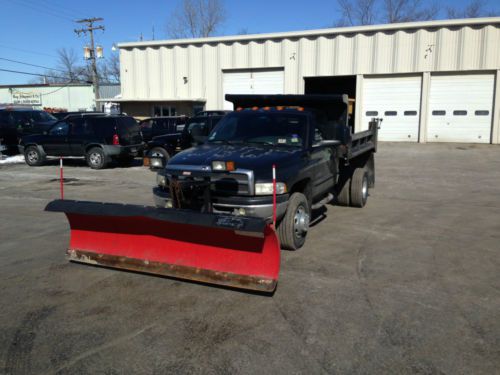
[153,186,289,220]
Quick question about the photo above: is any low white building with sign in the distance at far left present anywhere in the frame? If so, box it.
[0,84,120,111]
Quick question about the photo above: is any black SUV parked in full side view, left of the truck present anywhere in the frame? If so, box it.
[19,115,143,169]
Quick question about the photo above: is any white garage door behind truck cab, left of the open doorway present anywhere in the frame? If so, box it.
[223,70,284,109]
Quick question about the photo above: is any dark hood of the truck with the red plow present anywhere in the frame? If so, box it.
[168,144,303,178]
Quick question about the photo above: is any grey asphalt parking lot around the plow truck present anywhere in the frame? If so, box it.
[0,143,500,374]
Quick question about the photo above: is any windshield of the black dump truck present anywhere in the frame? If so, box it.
[208,112,307,147]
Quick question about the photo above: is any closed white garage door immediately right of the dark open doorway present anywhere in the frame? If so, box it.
[361,76,421,142]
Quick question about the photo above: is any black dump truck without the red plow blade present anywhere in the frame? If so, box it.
[153,95,379,250]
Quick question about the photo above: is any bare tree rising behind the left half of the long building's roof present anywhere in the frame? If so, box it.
[167,0,226,39]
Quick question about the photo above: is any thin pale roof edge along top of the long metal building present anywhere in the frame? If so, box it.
[118,17,500,48]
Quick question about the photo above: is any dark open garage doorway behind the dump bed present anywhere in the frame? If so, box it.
[304,76,356,131]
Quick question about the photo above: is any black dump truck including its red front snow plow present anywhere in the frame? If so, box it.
[46,95,379,293]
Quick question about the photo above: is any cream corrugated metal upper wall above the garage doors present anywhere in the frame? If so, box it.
[120,25,500,109]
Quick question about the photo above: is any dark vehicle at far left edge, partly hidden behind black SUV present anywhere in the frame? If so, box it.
[0,107,57,151]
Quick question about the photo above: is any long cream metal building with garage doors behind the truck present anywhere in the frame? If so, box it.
[119,18,500,143]
